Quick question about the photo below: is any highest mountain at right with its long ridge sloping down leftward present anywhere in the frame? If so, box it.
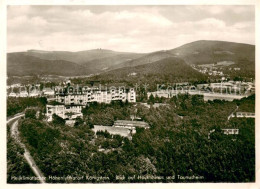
[110,40,255,73]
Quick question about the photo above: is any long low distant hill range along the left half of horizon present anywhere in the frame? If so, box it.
[7,49,143,76]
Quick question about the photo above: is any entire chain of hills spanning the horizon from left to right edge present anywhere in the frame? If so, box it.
[7,40,255,77]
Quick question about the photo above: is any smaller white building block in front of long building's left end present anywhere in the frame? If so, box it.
[46,105,83,121]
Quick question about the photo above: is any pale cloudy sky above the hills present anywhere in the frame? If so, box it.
[7,5,255,53]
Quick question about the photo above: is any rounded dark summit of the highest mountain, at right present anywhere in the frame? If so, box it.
[168,40,255,64]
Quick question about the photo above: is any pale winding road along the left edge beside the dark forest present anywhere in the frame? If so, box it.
[7,113,45,183]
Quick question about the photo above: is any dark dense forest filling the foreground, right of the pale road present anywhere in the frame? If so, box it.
[8,95,255,183]
